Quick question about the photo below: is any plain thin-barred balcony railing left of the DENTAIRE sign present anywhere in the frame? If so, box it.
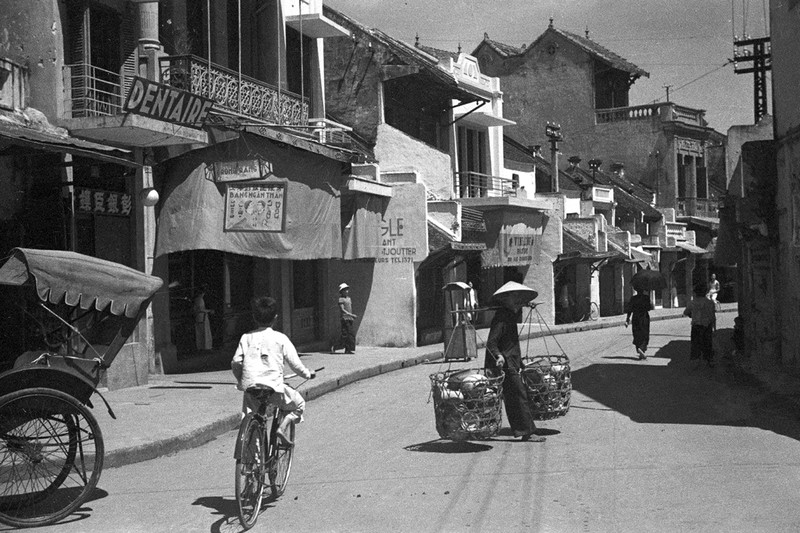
[62,63,126,118]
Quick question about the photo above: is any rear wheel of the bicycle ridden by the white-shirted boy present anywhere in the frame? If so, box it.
[236,413,264,529]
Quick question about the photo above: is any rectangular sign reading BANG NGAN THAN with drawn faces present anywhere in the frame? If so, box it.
[225,183,286,233]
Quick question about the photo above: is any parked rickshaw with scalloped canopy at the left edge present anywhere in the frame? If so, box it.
[0,248,162,527]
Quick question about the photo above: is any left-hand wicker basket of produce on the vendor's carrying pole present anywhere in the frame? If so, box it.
[431,368,503,441]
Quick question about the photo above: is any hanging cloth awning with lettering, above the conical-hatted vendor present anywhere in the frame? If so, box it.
[481,211,544,268]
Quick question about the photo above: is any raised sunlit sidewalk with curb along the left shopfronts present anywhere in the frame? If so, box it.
[98,303,736,468]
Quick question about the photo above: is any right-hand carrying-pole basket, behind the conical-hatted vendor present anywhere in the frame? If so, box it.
[522,355,572,420]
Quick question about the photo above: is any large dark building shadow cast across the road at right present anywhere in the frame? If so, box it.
[572,329,800,440]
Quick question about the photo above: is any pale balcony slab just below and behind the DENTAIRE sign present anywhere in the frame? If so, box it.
[59,113,208,148]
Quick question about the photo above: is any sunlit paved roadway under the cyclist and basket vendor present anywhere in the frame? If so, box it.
[18,313,800,532]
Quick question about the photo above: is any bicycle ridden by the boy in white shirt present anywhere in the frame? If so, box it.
[234,367,324,530]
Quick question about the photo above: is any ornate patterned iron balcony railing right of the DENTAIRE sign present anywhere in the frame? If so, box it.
[160,55,309,126]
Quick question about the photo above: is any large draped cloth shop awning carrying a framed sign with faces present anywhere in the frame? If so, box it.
[156,134,342,260]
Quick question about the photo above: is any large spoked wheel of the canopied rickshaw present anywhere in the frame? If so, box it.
[0,388,104,527]
